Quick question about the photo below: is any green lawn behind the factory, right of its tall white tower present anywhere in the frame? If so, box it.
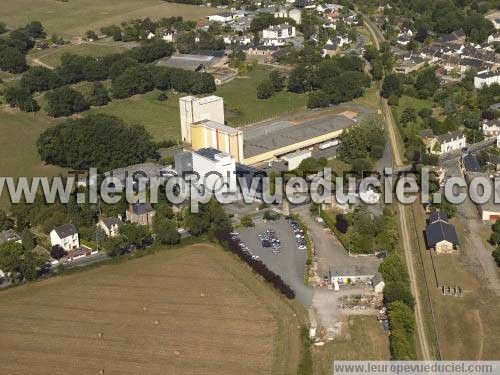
[215,66,307,126]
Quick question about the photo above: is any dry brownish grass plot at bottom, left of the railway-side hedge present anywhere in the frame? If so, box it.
[313,316,390,375]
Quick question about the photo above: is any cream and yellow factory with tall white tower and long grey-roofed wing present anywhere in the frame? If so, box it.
[179,95,356,165]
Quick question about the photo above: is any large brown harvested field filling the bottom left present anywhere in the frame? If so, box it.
[0,244,303,375]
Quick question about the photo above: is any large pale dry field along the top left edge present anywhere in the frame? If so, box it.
[0,0,217,38]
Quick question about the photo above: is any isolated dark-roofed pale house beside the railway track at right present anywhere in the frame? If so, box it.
[425,212,458,254]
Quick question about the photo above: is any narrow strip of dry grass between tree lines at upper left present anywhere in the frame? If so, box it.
[28,44,125,67]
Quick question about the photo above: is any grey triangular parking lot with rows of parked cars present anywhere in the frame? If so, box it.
[237,218,313,306]
